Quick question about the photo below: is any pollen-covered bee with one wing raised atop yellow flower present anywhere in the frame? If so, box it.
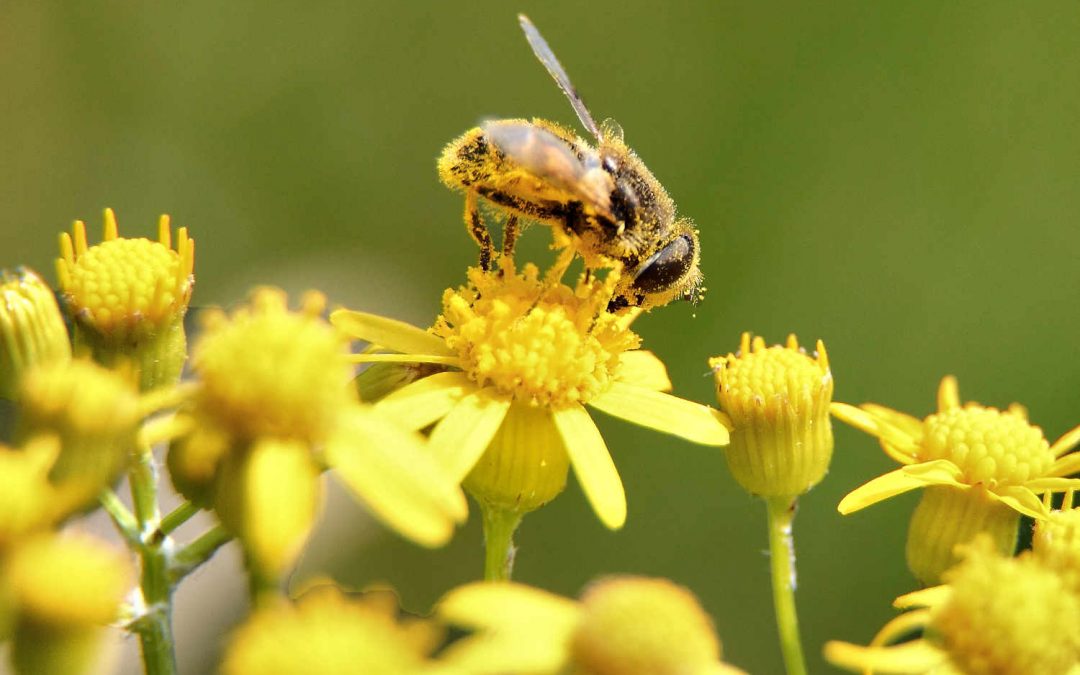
[438,14,701,311]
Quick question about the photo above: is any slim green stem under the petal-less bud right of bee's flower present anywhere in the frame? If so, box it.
[765,497,807,675]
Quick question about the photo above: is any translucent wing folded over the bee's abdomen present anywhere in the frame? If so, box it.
[482,120,615,214]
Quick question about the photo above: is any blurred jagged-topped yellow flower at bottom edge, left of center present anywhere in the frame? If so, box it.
[221,586,453,675]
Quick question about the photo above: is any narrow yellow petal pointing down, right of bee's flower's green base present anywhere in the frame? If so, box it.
[553,406,626,529]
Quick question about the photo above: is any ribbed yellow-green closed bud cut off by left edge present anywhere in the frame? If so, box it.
[0,267,71,399]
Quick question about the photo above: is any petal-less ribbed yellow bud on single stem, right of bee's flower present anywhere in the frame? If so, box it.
[710,333,833,498]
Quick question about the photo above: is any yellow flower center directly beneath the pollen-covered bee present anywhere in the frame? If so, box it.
[434,264,640,407]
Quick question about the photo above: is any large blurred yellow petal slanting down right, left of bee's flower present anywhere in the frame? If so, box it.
[326,409,468,546]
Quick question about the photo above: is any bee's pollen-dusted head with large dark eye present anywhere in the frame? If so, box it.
[608,220,701,312]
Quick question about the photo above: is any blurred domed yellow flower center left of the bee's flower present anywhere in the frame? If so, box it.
[192,288,355,443]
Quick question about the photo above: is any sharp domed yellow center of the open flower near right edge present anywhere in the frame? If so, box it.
[919,405,1054,487]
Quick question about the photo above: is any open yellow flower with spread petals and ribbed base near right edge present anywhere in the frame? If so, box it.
[832,377,1080,585]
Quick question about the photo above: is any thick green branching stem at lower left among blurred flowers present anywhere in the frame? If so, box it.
[127,446,176,675]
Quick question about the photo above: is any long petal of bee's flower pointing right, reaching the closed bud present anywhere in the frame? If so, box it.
[589,382,728,445]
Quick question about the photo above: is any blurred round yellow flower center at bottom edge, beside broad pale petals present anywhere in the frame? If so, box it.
[570,577,720,675]
